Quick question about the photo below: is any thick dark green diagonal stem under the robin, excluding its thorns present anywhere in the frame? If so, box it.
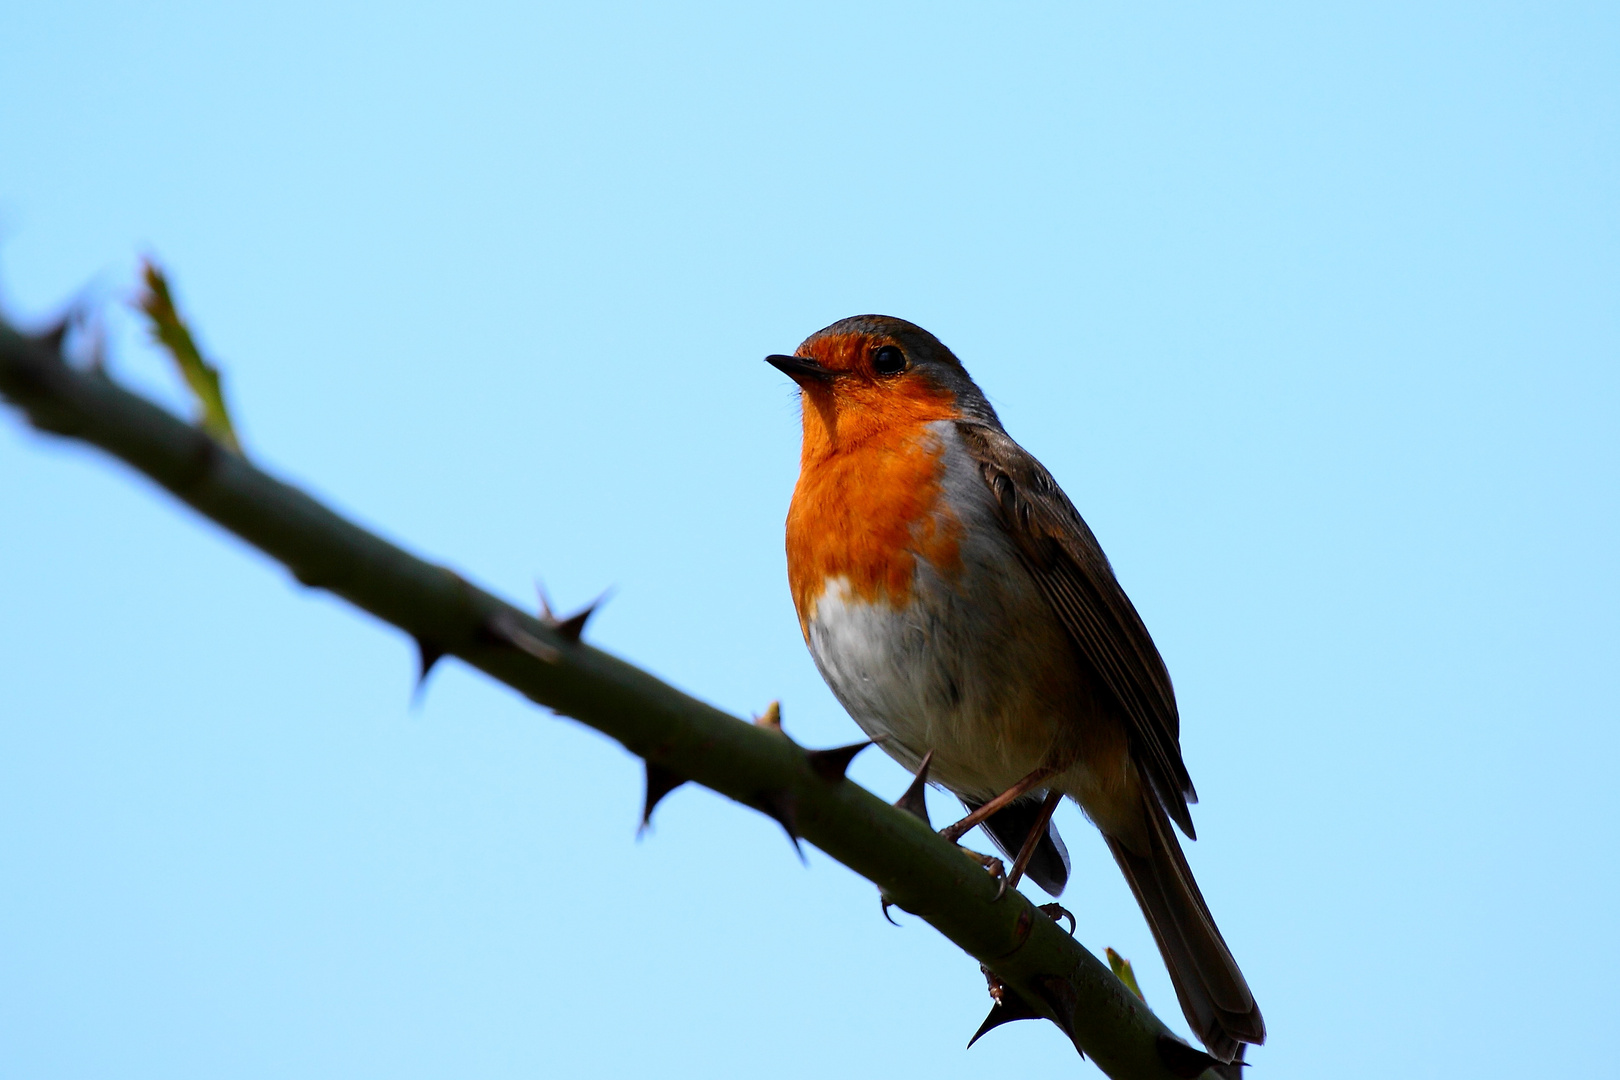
[0,321,1236,1080]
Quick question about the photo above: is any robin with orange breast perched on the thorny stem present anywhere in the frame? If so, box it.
[765,314,1265,1062]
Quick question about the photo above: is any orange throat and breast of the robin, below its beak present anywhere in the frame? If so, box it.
[787,390,962,638]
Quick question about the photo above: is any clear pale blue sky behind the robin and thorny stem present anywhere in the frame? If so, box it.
[0,0,1620,1080]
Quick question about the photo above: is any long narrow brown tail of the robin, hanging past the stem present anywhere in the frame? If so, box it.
[1106,803,1265,1061]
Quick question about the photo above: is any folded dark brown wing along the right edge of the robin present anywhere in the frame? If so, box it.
[957,421,1199,839]
